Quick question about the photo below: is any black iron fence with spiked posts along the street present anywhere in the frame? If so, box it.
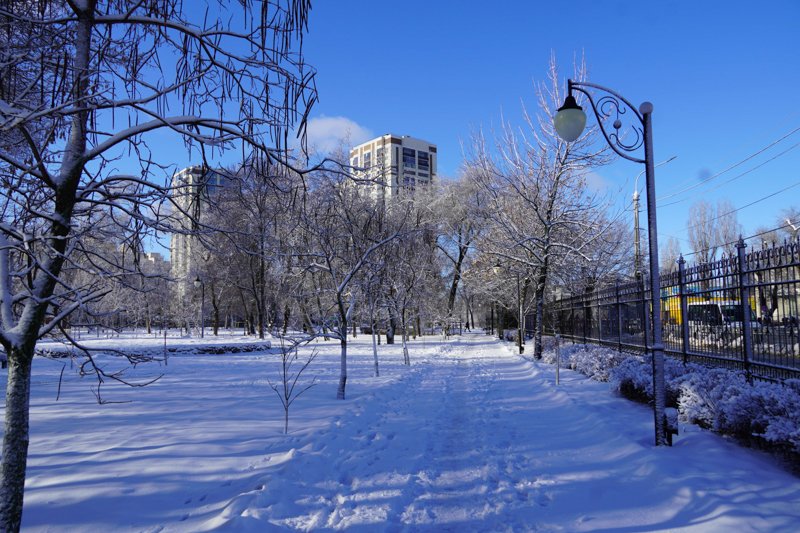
[545,240,800,380]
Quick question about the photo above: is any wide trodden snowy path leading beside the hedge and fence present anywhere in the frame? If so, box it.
[204,337,800,531]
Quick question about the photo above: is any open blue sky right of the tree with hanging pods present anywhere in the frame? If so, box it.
[298,0,800,252]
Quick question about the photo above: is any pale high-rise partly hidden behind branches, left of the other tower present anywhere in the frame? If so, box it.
[170,166,225,299]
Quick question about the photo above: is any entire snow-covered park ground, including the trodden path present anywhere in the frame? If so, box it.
[4,334,800,532]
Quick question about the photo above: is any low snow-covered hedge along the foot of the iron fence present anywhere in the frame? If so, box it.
[543,343,800,453]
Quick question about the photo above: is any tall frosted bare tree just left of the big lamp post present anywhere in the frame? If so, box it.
[469,59,607,358]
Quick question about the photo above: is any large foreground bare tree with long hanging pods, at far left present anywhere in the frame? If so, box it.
[0,0,316,531]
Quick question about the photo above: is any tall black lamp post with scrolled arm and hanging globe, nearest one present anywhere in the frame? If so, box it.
[553,80,667,446]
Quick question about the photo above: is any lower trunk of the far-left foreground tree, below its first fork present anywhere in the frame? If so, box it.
[0,347,33,531]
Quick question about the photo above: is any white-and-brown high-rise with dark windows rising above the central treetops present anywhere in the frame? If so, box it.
[350,133,437,198]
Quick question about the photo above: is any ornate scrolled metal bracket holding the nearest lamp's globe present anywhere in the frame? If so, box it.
[567,80,645,164]
